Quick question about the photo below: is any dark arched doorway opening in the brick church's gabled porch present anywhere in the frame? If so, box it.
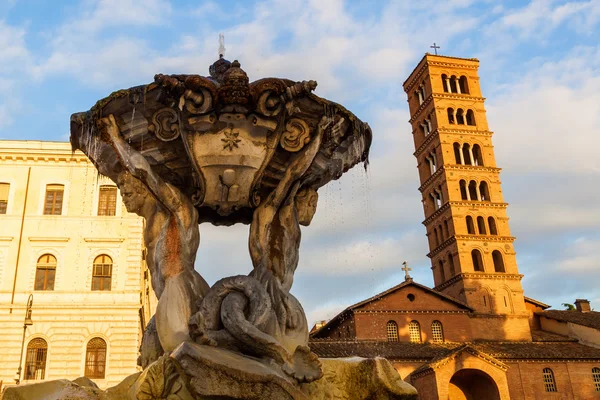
[448,369,500,400]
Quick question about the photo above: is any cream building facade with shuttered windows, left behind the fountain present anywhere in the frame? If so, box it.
[0,141,156,388]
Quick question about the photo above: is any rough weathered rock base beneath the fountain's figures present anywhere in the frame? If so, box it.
[2,354,417,400]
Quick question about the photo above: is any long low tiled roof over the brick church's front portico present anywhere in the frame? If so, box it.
[309,339,600,363]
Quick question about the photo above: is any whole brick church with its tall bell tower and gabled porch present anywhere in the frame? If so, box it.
[311,54,600,400]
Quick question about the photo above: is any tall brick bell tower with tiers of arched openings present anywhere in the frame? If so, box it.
[403,53,531,340]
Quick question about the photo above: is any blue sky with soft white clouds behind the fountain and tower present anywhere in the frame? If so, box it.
[0,0,600,326]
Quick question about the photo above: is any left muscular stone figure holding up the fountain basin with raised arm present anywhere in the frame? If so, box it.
[100,115,209,358]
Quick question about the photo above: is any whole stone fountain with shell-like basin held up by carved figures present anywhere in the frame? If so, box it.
[1,56,416,399]
